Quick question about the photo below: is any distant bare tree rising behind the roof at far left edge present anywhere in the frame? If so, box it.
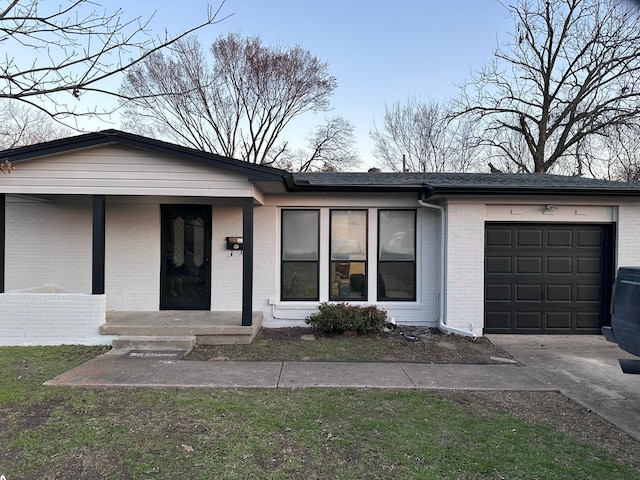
[0,100,72,150]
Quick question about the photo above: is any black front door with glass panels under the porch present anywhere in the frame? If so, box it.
[160,205,211,310]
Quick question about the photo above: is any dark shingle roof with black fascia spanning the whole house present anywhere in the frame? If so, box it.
[5,130,640,196]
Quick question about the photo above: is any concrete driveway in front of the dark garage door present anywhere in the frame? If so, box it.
[487,335,640,440]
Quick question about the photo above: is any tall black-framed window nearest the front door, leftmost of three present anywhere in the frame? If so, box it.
[280,210,320,300]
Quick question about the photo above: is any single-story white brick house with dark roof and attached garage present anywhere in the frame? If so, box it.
[0,130,640,345]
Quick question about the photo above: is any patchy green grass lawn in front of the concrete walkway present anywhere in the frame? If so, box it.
[0,347,639,480]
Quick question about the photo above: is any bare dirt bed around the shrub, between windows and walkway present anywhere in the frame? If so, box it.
[186,327,515,364]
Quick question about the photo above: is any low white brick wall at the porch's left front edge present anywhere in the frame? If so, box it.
[0,287,113,345]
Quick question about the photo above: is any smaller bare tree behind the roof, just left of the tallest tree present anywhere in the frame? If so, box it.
[370,96,476,172]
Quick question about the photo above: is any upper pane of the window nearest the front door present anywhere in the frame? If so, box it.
[282,210,318,260]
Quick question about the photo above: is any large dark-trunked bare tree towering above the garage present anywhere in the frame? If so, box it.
[456,0,640,174]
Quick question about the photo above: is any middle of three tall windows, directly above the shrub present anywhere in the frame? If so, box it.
[329,210,367,300]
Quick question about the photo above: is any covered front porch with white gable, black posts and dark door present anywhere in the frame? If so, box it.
[0,131,284,344]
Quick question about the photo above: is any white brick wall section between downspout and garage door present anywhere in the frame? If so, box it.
[445,204,485,335]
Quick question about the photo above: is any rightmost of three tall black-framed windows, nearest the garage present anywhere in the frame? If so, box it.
[378,210,416,301]
